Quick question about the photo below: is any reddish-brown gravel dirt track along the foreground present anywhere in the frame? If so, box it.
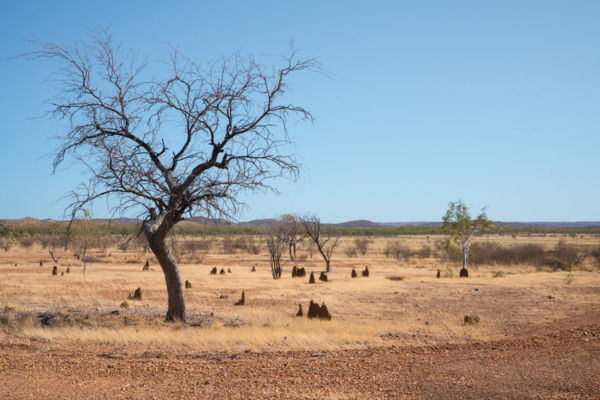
[0,315,600,399]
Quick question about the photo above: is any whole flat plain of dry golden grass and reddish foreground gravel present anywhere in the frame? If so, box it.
[0,235,600,399]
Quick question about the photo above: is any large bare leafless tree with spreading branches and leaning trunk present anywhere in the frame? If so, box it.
[25,31,319,321]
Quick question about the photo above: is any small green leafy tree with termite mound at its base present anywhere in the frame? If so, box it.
[442,199,491,277]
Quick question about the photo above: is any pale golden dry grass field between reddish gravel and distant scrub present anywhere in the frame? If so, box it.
[0,236,600,351]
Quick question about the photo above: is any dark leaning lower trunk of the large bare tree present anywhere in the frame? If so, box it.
[144,228,185,322]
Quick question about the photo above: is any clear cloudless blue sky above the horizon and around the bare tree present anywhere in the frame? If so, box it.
[0,0,600,222]
